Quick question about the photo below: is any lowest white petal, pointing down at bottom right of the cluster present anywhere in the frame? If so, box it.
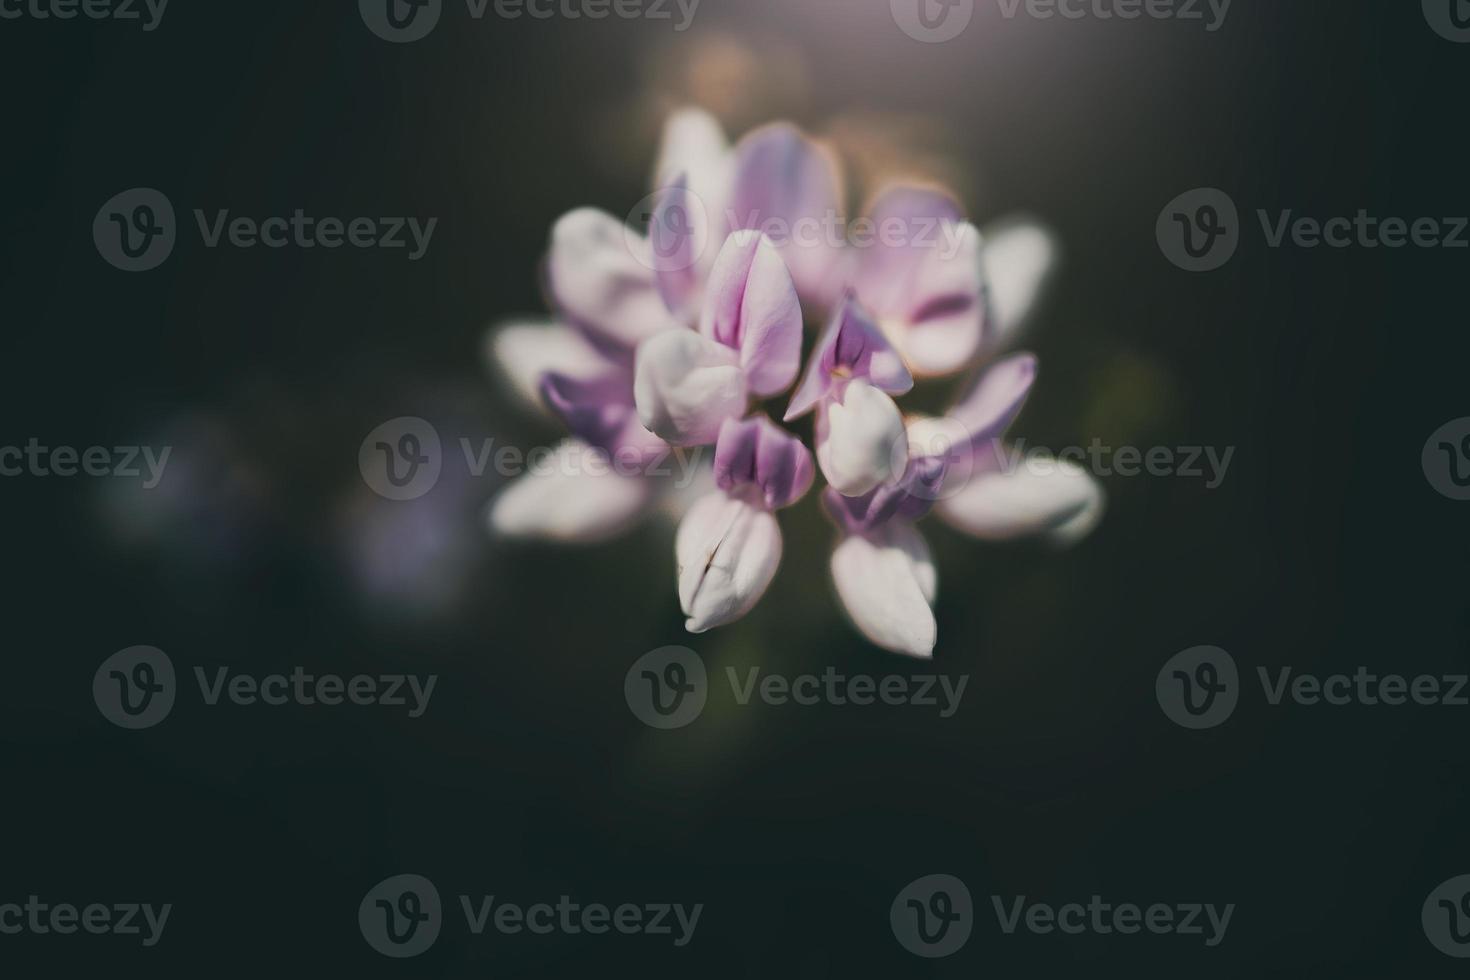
[832,525,938,658]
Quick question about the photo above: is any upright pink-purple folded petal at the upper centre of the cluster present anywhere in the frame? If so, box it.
[700,231,801,398]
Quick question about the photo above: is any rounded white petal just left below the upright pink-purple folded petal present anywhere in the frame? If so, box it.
[634,329,747,445]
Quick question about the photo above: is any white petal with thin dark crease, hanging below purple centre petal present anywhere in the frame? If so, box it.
[673,491,781,633]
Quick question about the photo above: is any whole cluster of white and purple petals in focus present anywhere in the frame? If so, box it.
[490,110,1103,657]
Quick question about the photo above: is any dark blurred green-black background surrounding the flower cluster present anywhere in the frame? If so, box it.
[0,0,1470,980]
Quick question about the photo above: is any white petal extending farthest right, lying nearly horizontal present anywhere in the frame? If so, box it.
[936,455,1104,544]
